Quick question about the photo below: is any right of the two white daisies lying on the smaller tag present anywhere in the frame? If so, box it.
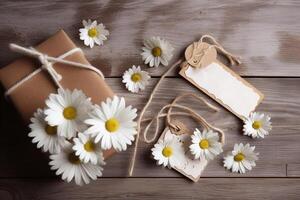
[190,128,223,160]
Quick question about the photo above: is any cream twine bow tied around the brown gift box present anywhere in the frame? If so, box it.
[5,44,104,96]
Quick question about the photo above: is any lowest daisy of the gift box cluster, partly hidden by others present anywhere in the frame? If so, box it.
[49,144,103,185]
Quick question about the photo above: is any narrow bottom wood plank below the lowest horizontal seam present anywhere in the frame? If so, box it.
[0,178,300,200]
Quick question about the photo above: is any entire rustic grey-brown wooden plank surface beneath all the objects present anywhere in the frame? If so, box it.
[0,0,300,199]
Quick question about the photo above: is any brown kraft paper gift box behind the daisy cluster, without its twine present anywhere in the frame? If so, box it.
[0,30,114,157]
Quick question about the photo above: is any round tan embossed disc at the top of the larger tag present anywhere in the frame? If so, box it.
[185,41,217,68]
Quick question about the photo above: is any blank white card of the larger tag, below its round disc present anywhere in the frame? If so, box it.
[184,62,263,119]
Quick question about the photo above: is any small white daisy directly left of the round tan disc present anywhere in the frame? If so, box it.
[141,37,174,67]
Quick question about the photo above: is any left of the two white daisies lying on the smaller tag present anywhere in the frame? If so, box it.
[151,134,184,168]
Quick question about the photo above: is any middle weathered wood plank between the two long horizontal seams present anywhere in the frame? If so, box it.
[0,78,300,177]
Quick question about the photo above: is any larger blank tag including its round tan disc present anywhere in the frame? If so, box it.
[179,42,263,120]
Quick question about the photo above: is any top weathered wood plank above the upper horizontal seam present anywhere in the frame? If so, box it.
[0,0,300,76]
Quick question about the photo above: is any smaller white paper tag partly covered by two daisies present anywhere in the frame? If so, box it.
[160,127,207,182]
